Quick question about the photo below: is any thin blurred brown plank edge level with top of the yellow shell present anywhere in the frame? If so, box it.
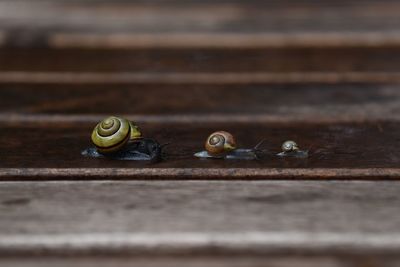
[0,113,400,127]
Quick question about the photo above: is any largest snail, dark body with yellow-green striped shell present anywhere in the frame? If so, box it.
[82,117,162,162]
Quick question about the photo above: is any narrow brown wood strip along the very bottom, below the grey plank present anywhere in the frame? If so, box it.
[0,255,399,267]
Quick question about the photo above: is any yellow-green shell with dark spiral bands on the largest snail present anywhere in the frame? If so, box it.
[92,117,141,154]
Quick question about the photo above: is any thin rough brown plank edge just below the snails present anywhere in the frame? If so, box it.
[0,169,400,180]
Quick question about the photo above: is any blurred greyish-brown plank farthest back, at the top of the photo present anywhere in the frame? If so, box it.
[0,0,400,47]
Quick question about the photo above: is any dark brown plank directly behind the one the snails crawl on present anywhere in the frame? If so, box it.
[0,84,400,124]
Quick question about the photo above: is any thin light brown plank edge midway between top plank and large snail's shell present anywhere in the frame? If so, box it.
[0,71,400,85]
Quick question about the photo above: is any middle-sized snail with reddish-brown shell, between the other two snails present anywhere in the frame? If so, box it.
[194,131,264,160]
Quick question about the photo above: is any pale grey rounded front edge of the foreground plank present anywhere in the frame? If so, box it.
[0,232,400,256]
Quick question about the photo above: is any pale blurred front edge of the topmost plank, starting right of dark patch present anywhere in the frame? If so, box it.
[48,31,400,49]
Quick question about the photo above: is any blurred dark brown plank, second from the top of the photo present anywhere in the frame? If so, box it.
[0,45,400,73]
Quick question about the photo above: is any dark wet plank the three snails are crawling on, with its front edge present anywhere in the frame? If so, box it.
[0,121,400,180]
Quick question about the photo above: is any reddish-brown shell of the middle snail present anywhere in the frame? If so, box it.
[205,131,236,155]
